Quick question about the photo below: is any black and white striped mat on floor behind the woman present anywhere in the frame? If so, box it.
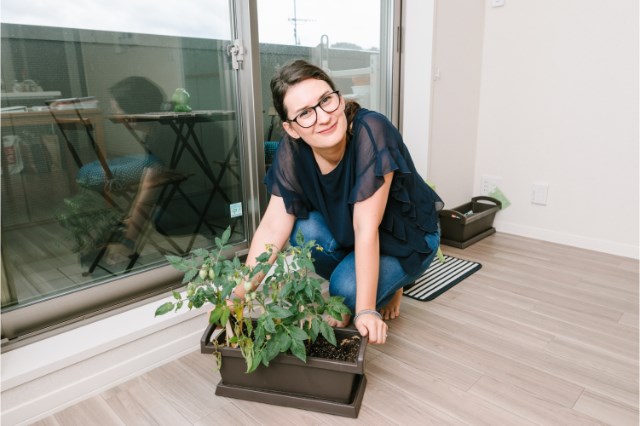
[403,256,482,302]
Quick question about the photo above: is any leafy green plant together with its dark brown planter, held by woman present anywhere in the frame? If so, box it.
[156,229,367,417]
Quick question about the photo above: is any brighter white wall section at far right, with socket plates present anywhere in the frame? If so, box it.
[478,0,639,257]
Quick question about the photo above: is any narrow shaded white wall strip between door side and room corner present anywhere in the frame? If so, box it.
[424,0,485,208]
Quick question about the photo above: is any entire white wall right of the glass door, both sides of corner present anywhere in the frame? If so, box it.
[408,0,640,258]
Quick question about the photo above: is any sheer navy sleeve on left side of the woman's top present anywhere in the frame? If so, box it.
[264,135,310,219]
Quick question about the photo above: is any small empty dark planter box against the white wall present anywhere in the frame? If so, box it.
[440,196,502,248]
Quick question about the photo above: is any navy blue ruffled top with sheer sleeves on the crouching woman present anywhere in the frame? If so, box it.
[265,108,444,274]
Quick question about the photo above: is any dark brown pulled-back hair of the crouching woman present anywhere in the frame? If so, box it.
[271,59,360,131]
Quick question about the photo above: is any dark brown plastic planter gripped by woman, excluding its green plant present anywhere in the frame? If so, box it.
[200,324,367,417]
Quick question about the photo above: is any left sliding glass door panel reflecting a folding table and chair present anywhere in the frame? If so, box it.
[1,0,255,338]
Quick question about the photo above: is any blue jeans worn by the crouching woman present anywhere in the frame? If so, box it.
[289,211,440,312]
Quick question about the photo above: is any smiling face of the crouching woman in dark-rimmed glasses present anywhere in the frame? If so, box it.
[283,79,347,149]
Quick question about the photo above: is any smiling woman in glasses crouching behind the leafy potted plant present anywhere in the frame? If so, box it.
[235,60,443,344]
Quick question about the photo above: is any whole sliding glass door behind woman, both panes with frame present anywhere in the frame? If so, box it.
[0,0,400,344]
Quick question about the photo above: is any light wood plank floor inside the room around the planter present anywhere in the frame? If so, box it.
[31,233,638,426]
